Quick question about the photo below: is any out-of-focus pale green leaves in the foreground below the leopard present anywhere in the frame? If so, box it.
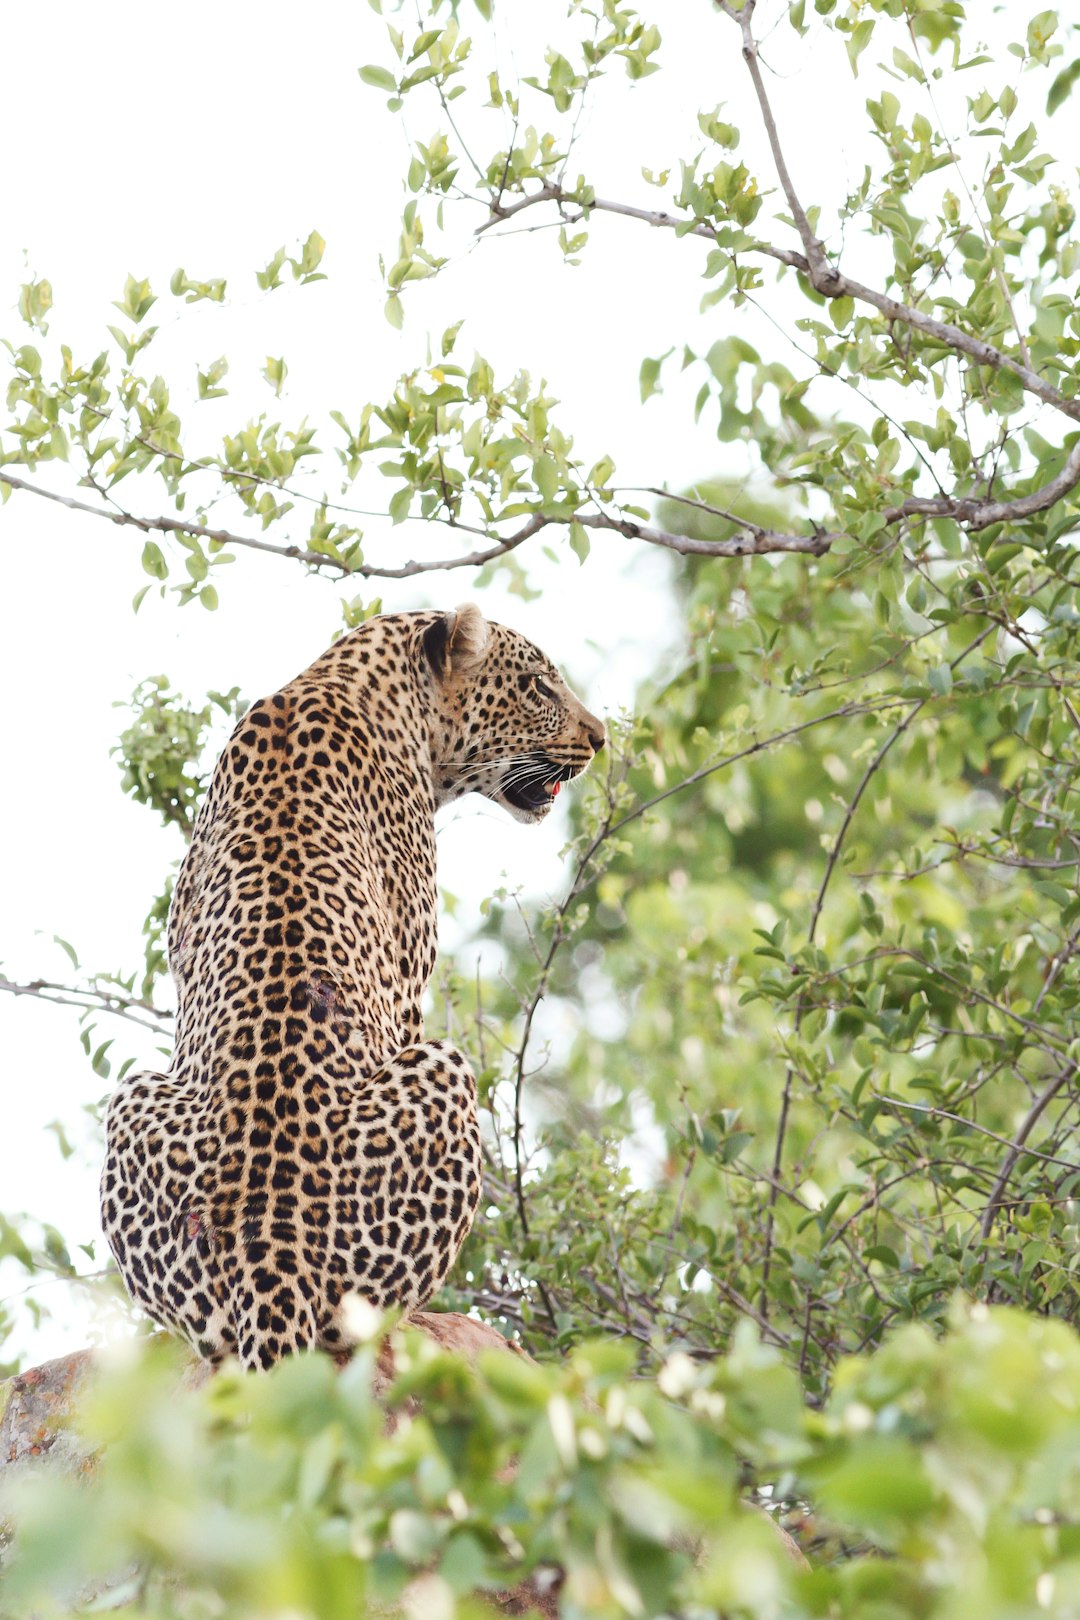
[0,1306,1080,1620]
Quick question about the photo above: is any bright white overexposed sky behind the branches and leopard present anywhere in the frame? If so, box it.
[0,0,1049,1356]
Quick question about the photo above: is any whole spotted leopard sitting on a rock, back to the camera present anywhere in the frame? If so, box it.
[100,603,606,1369]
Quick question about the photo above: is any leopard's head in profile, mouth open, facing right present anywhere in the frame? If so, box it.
[421,603,604,821]
